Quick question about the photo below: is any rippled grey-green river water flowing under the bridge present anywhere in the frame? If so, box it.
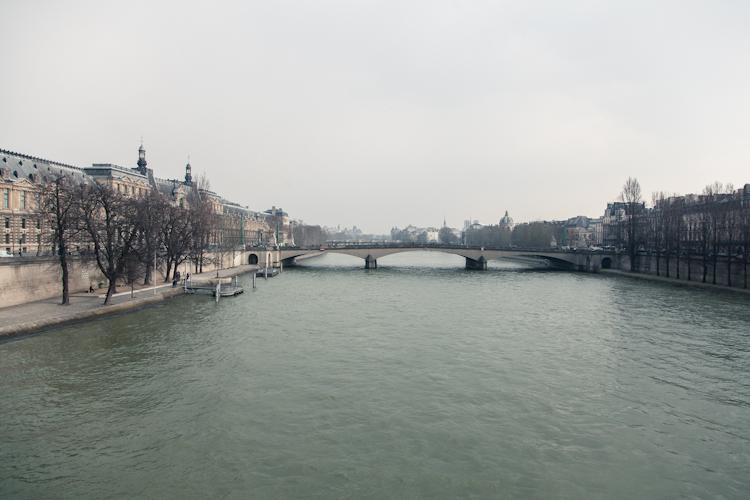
[0,252,750,499]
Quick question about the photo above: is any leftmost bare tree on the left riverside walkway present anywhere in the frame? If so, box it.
[39,173,81,306]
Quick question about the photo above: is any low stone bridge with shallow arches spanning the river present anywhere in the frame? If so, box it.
[246,244,619,272]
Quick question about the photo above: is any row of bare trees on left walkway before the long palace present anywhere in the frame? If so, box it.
[40,174,217,305]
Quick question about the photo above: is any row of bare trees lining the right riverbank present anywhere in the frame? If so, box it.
[605,178,750,288]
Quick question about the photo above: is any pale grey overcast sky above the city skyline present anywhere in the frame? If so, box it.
[0,0,750,233]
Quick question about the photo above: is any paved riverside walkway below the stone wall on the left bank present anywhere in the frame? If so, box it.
[0,265,258,341]
